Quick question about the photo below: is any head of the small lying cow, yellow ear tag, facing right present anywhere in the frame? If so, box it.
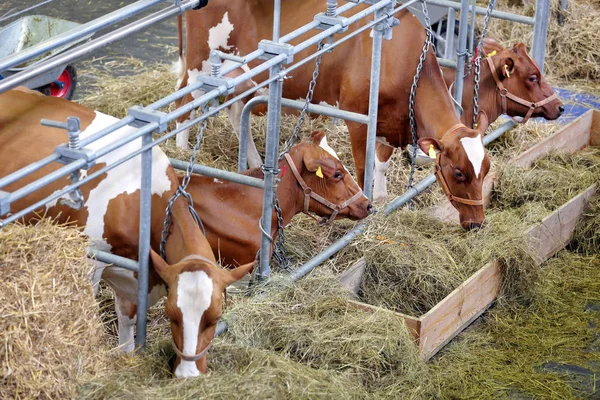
[288,131,372,221]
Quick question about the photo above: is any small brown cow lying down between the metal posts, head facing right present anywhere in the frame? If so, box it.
[188,132,371,265]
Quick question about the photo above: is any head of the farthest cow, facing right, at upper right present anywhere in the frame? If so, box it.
[482,39,564,120]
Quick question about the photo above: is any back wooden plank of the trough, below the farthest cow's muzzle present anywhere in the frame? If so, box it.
[514,111,592,168]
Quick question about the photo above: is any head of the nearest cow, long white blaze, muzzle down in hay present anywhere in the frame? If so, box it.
[151,250,254,378]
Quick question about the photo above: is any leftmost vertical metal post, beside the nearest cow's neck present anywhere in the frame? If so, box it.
[135,133,152,349]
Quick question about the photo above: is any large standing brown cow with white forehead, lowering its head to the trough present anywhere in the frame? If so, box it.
[178,0,489,228]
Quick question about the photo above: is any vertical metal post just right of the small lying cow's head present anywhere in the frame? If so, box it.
[364,28,383,200]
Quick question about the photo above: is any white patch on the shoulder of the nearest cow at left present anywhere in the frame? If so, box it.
[81,111,171,251]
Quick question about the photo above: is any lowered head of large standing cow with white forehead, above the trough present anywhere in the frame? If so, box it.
[418,113,490,230]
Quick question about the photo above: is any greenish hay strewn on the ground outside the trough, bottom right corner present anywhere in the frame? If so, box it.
[430,251,600,399]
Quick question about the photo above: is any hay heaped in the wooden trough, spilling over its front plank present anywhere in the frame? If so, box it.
[358,210,536,316]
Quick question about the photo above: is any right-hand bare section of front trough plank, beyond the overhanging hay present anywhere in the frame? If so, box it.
[527,184,596,264]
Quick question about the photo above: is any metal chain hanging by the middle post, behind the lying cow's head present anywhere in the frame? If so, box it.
[268,40,324,271]
